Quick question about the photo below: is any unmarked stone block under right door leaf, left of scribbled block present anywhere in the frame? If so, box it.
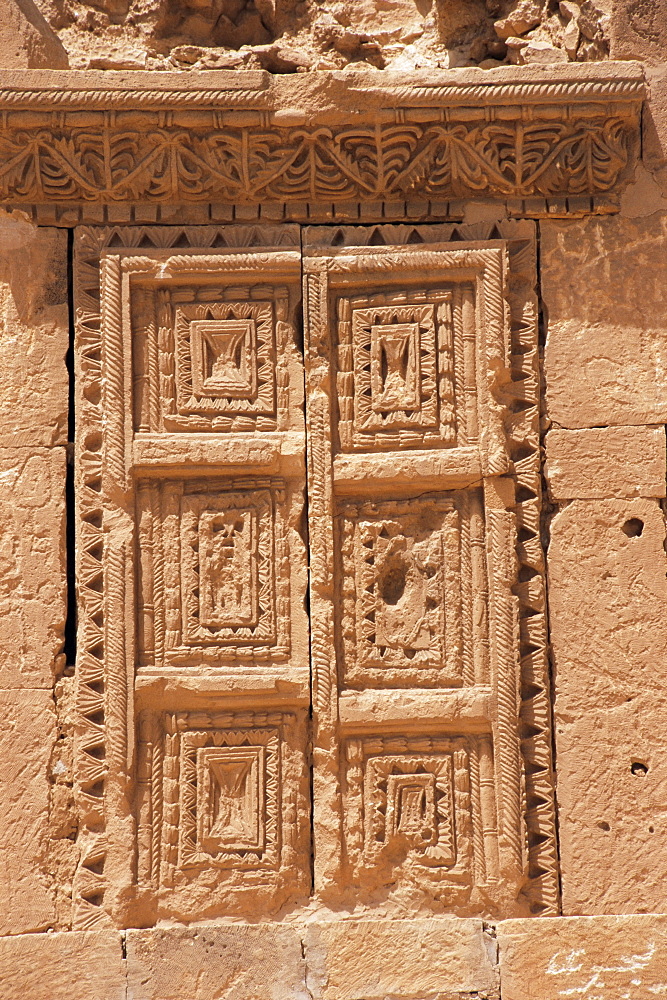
[306,917,498,1000]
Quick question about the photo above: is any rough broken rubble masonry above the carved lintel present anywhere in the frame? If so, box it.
[32,0,609,73]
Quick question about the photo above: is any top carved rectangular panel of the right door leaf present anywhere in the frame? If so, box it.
[338,291,456,451]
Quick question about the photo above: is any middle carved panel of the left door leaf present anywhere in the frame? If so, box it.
[139,479,291,666]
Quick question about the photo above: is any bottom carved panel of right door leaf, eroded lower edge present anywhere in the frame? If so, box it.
[344,735,497,903]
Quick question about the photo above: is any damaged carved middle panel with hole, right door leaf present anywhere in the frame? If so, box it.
[341,494,469,687]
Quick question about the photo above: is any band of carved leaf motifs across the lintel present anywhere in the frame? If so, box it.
[0,117,633,202]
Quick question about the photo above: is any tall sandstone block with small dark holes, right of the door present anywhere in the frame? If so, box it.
[549,499,667,915]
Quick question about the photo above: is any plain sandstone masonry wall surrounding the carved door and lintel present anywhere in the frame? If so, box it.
[0,0,667,1000]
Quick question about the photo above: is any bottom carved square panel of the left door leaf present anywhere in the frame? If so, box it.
[136,698,310,919]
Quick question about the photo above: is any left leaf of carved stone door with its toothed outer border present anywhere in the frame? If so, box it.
[74,226,310,928]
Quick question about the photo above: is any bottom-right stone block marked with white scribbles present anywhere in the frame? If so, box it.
[496,914,667,1000]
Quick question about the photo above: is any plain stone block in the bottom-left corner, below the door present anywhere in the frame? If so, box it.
[0,931,129,1000]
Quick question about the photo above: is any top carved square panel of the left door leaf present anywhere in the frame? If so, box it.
[131,280,293,431]
